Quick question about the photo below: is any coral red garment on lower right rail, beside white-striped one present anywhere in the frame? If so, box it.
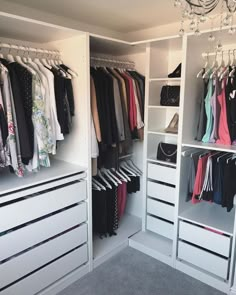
[192,154,210,204]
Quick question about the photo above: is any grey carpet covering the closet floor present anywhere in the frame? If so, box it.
[58,248,223,295]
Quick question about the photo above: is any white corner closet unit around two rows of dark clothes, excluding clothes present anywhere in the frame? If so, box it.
[90,36,146,267]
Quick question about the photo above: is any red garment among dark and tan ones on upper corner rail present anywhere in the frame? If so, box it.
[122,73,137,131]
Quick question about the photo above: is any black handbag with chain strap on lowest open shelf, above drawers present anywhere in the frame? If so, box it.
[157,142,177,163]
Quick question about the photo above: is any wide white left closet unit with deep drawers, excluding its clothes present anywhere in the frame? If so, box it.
[0,13,91,295]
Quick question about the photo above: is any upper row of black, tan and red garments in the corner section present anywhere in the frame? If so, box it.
[90,63,145,172]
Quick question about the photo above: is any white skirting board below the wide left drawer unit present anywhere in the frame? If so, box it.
[38,264,89,295]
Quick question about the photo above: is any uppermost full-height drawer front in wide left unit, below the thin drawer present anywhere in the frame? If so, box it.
[0,181,86,232]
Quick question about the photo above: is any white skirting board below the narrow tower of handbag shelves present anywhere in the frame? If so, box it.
[129,239,173,266]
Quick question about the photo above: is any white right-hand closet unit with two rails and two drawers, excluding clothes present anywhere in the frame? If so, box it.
[175,30,235,293]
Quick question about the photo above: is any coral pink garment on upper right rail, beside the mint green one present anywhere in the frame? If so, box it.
[216,79,231,145]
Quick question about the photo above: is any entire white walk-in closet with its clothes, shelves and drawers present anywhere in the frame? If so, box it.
[0,0,236,295]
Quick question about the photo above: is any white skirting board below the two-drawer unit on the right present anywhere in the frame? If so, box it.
[176,260,229,294]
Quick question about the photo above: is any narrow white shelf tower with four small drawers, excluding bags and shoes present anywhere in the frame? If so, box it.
[130,37,182,265]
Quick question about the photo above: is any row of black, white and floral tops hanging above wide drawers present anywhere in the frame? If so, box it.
[0,54,75,176]
